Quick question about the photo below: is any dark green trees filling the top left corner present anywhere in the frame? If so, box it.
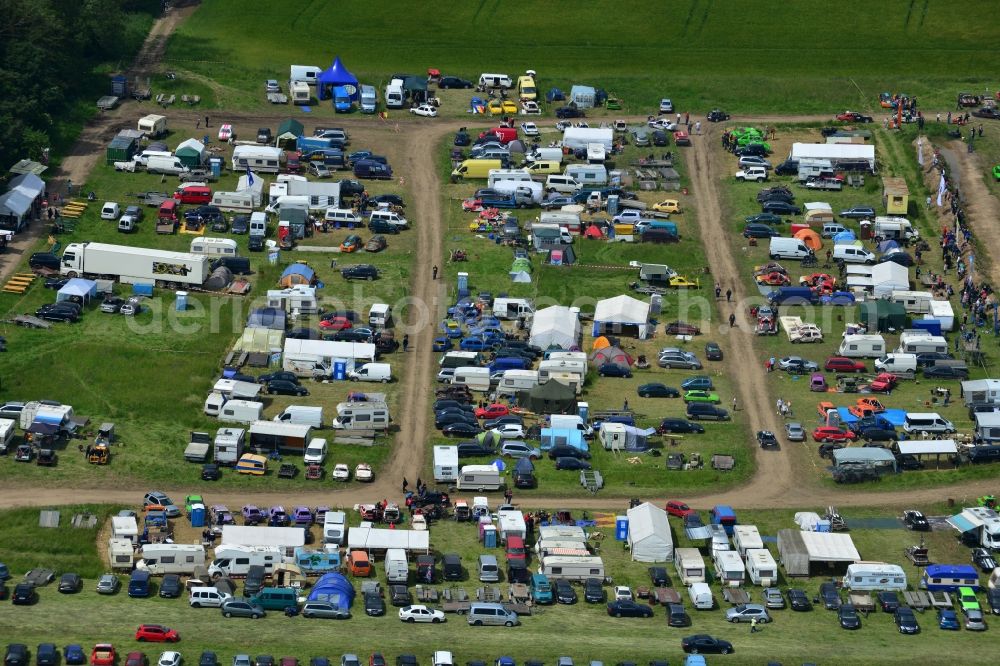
[0,0,162,174]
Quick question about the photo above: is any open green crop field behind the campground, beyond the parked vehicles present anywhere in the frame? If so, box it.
[165,0,998,113]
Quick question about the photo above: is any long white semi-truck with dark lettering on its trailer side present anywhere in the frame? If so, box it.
[59,243,211,286]
